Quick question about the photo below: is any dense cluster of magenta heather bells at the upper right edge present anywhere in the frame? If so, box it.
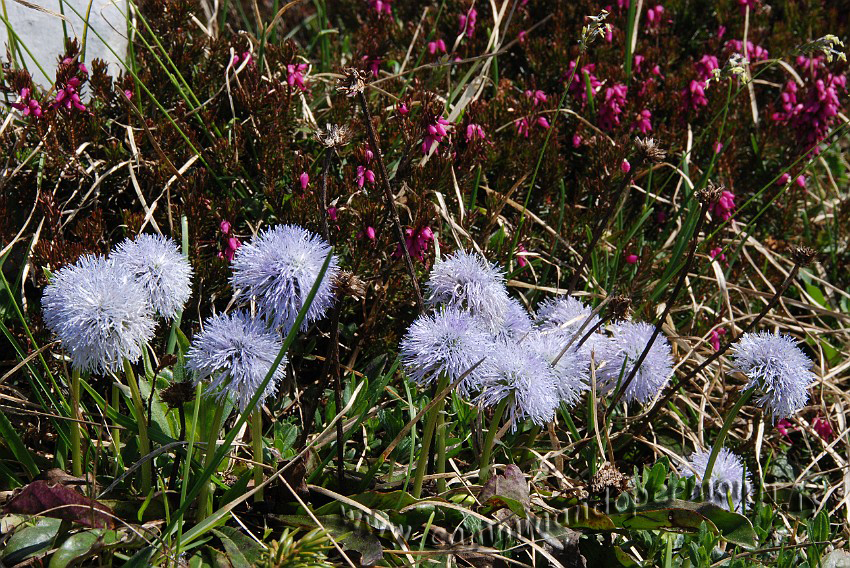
[771,56,847,153]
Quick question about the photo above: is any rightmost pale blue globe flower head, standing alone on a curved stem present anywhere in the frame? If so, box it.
[732,331,816,419]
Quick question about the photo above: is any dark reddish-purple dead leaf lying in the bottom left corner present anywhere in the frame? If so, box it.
[6,481,115,529]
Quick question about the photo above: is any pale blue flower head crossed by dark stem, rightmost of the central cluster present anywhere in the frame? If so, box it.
[596,322,673,404]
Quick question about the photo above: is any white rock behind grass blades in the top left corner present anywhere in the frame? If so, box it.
[0,0,127,89]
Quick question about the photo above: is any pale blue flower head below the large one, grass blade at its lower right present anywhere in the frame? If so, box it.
[186,311,286,411]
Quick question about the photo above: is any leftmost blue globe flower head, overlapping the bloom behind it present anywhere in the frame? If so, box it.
[41,255,156,373]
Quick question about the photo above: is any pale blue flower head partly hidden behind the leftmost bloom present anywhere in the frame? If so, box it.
[110,234,192,319]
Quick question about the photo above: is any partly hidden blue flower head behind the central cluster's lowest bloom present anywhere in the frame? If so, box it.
[521,330,590,406]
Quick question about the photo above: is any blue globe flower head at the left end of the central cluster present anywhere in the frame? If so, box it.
[400,307,493,397]
